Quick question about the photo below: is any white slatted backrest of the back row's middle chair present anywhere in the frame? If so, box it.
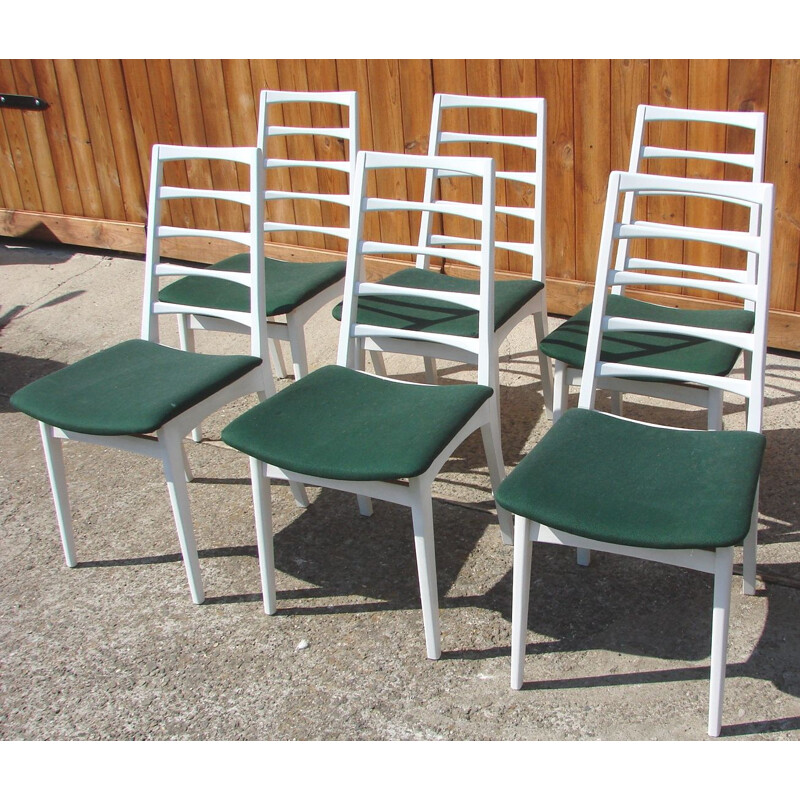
[417,94,547,282]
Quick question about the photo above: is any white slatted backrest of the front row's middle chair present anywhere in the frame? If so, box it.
[338,151,495,386]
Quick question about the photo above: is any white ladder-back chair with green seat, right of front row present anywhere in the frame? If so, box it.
[496,172,774,736]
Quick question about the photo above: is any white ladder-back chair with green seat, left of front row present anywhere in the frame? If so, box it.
[11,145,274,603]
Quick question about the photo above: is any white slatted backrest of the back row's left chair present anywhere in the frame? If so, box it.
[258,89,358,250]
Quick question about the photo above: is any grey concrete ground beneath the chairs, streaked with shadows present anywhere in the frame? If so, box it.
[0,240,800,741]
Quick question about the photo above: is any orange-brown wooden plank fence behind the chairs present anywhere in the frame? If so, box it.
[0,59,800,351]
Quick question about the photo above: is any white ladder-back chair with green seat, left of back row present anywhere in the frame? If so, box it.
[160,89,358,412]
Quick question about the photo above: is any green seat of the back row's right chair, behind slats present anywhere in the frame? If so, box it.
[541,295,755,375]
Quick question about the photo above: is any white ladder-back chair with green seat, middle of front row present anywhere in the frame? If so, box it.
[222,152,511,659]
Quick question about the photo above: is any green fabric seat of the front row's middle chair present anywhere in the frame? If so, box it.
[222,365,492,480]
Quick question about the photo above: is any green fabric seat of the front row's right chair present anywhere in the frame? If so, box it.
[495,408,766,550]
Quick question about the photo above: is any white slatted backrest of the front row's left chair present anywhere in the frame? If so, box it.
[142,144,268,363]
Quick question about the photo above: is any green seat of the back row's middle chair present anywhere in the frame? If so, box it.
[333,267,542,339]
